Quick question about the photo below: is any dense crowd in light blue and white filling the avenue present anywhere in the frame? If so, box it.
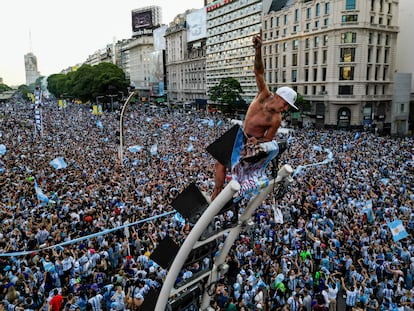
[0,101,414,311]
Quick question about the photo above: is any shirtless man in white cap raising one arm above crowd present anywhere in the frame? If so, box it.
[211,31,298,200]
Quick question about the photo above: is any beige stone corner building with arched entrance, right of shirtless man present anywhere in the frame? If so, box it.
[263,0,399,131]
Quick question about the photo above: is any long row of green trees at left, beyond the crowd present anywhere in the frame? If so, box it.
[47,63,129,102]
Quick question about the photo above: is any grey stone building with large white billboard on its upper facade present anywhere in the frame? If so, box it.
[165,9,207,105]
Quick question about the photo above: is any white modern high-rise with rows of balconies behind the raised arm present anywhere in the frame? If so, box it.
[206,0,262,103]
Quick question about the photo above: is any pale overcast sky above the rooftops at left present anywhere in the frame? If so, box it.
[0,0,204,86]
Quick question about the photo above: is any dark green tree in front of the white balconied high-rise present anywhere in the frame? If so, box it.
[209,78,244,112]
